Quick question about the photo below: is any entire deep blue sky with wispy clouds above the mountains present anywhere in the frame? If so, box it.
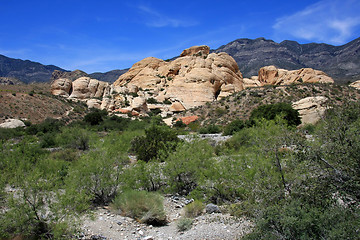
[0,0,360,73]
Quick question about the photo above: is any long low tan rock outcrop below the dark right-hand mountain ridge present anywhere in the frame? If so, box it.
[258,66,334,85]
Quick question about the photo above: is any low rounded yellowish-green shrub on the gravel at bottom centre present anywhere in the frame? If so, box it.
[112,190,167,226]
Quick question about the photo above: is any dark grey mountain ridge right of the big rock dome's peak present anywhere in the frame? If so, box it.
[213,38,360,82]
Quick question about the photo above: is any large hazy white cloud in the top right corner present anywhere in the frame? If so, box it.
[273,0,360,44]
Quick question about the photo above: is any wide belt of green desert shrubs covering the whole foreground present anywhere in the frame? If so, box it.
[0,96,360,239]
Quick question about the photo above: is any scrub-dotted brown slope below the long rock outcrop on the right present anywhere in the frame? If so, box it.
[177,84,360,125]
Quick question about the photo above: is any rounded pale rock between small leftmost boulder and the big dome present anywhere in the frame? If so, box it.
[69,77,110,99]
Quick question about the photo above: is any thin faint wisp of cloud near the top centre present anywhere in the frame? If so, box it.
[137,5,198,28]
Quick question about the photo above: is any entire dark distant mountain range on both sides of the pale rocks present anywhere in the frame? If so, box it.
[0,38,360,83]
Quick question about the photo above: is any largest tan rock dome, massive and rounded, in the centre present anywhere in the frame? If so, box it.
[114,46,243,109]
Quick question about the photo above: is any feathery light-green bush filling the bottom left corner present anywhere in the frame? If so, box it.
[0,162,87,239]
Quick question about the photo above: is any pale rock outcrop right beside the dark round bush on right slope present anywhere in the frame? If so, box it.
[292,96,328,125]
